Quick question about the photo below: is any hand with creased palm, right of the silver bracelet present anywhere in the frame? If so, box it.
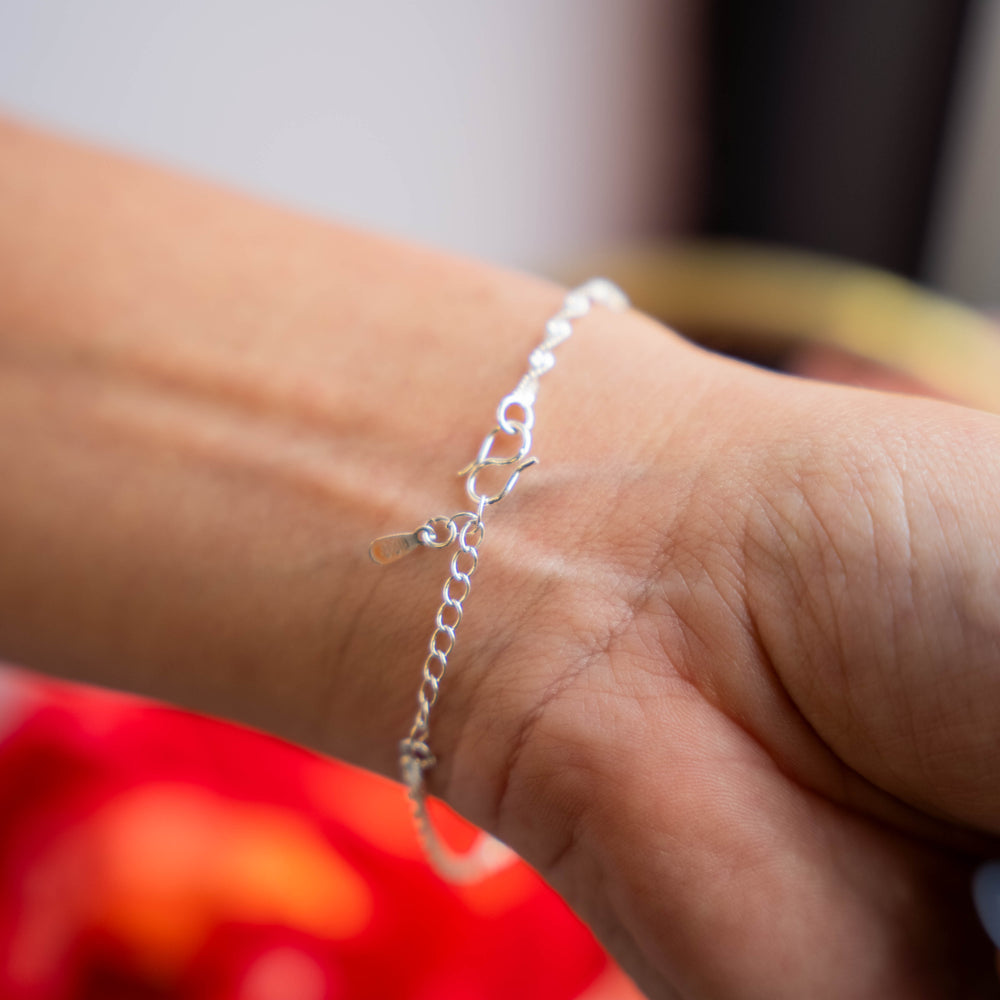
[441,320,1000,1000]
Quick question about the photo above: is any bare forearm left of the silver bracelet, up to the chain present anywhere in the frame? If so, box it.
[0,115,624,773]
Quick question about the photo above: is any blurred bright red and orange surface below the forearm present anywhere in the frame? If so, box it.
[0,669,638,1000]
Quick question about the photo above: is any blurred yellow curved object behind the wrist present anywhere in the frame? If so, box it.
[570,241,1000,412]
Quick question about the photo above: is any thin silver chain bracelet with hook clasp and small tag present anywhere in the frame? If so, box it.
[369,278,629,882]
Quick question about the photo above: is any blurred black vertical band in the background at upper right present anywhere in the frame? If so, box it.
[701,0,968,277]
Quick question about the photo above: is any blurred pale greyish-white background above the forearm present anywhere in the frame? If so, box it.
[0,0,697,268]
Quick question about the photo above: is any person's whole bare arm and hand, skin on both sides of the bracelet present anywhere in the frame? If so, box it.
[0,115,1000,1000]
